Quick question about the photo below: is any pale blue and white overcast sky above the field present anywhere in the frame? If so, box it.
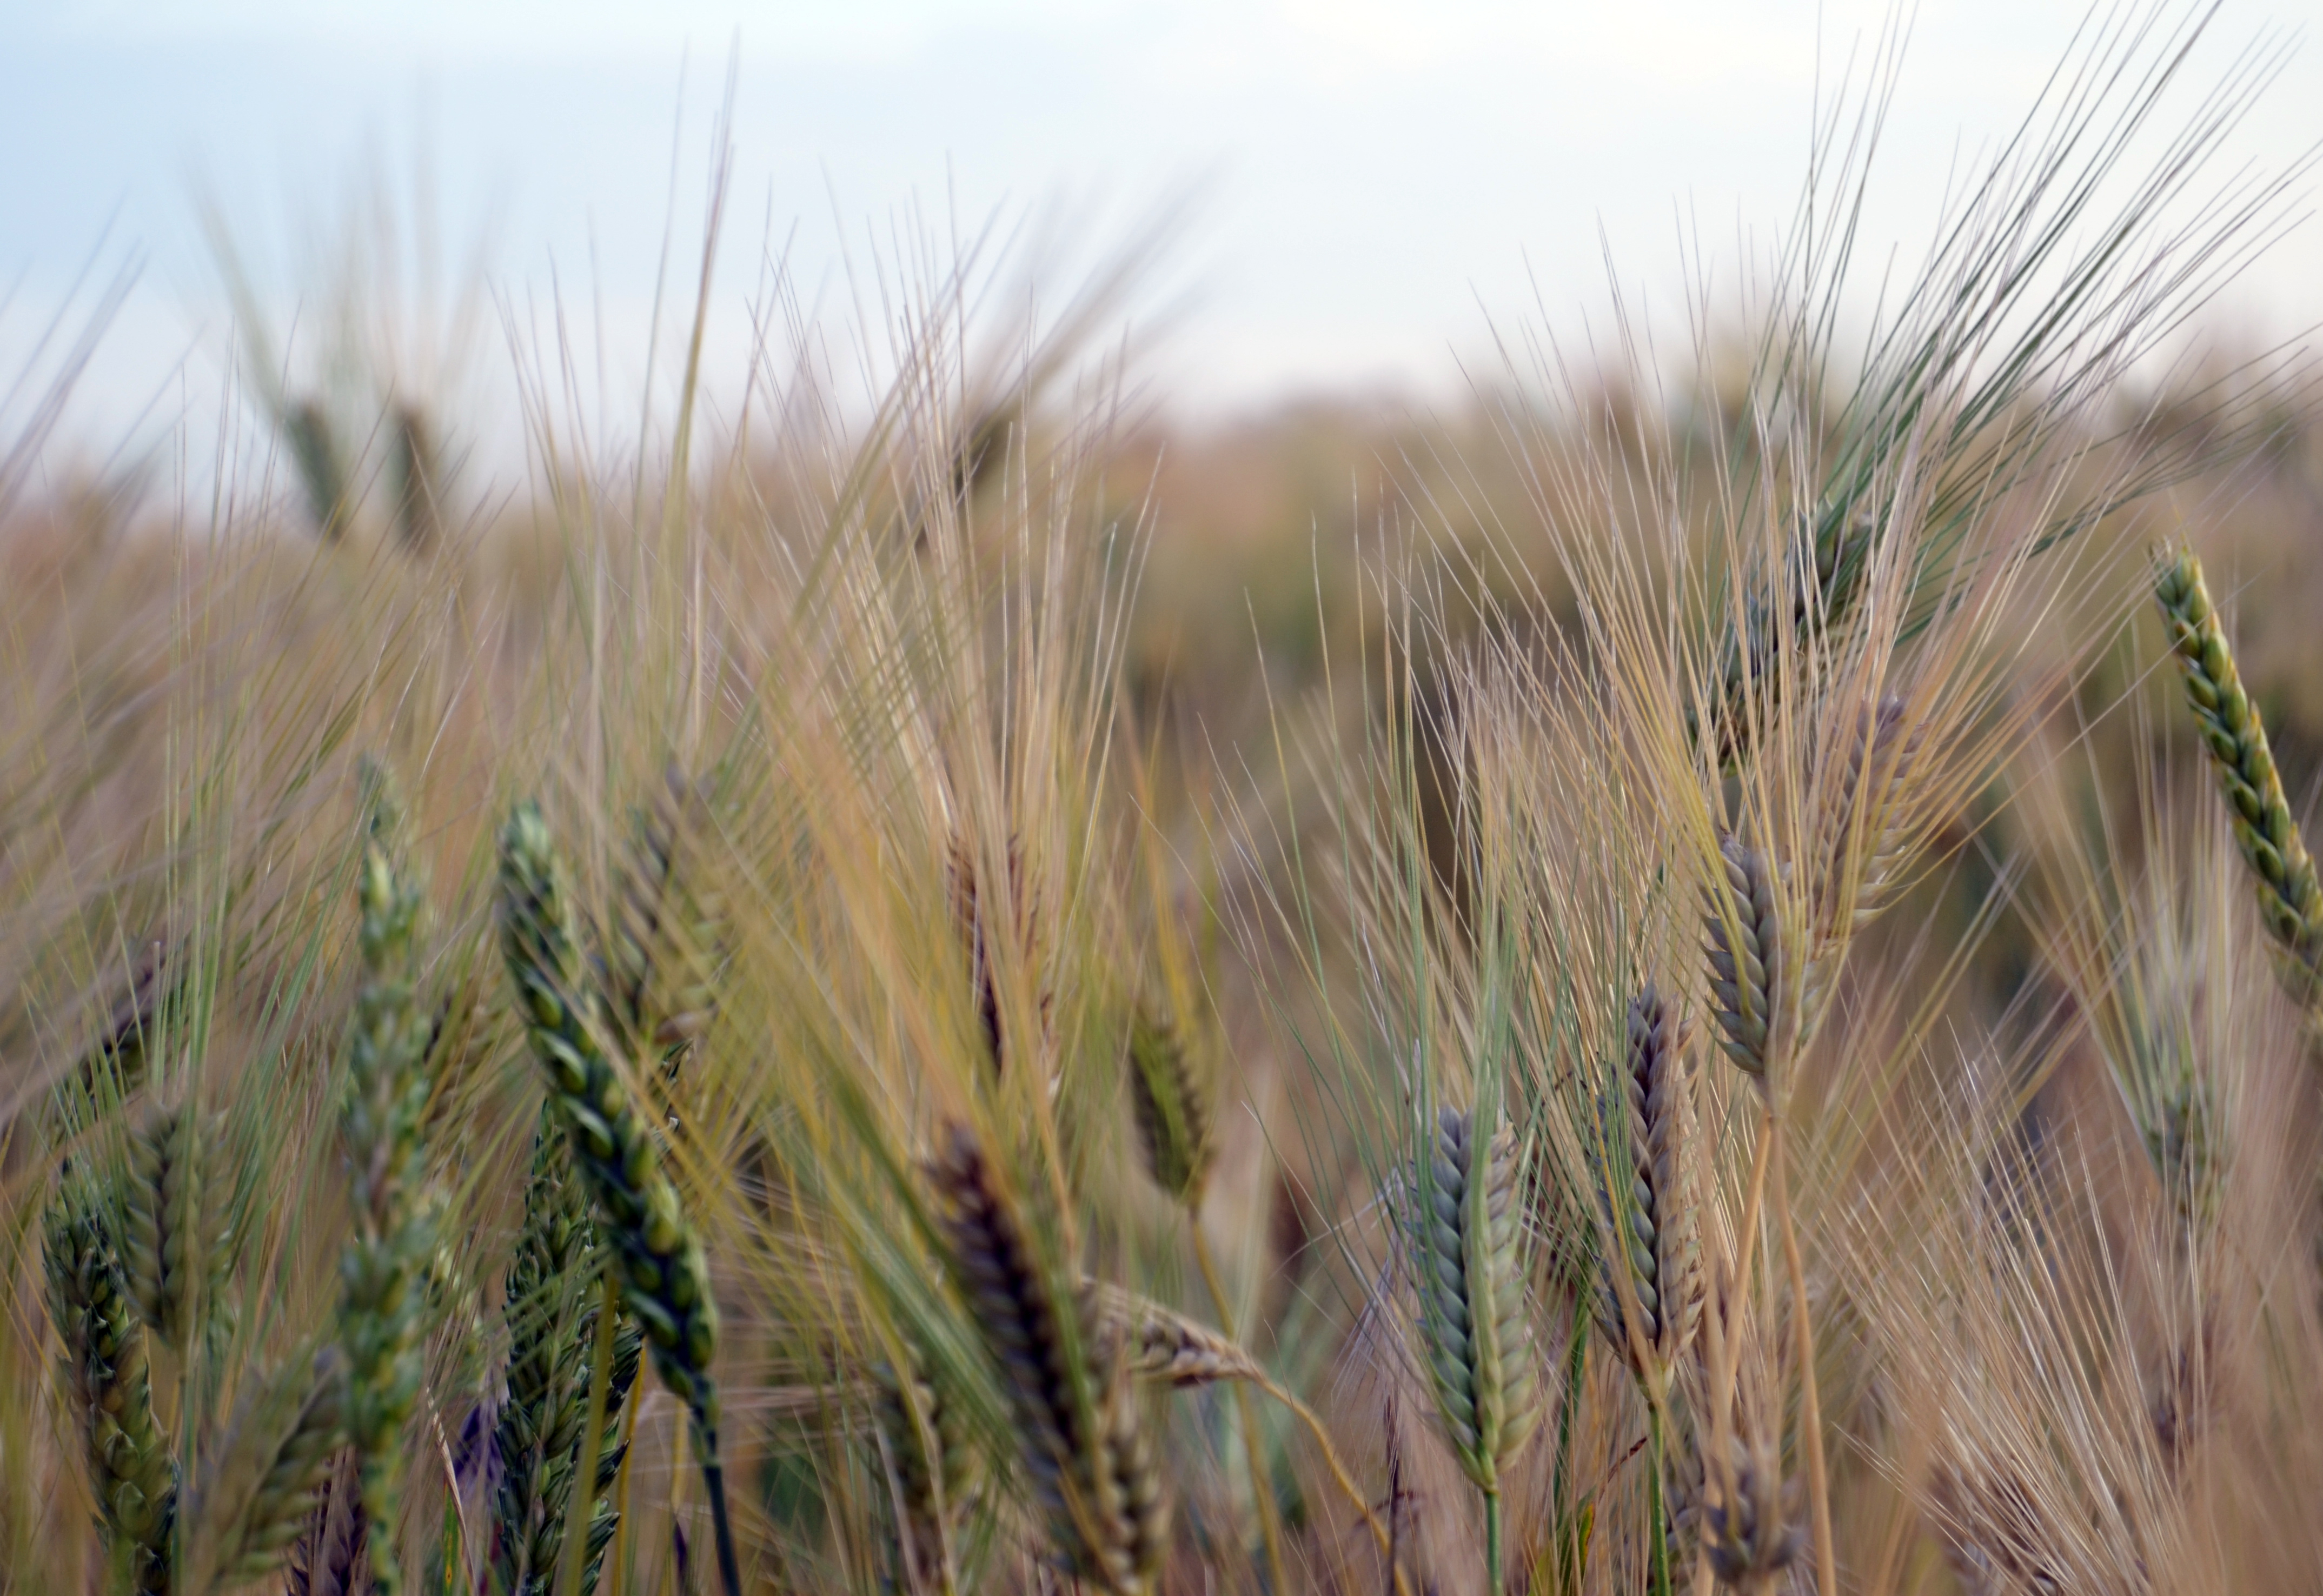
[0,0,2323,462]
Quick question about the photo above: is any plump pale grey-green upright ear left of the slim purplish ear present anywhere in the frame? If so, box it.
[1403,1108,1540,1505]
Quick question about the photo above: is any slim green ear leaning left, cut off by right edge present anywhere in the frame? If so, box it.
[2153,550,2323,1003]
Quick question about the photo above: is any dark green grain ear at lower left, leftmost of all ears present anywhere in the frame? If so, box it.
[42,1171,176,1596]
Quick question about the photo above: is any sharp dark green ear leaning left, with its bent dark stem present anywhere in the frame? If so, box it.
[500,799,741,1596]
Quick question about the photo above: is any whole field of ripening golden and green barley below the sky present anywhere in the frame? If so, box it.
[0,7,2323,1596]
